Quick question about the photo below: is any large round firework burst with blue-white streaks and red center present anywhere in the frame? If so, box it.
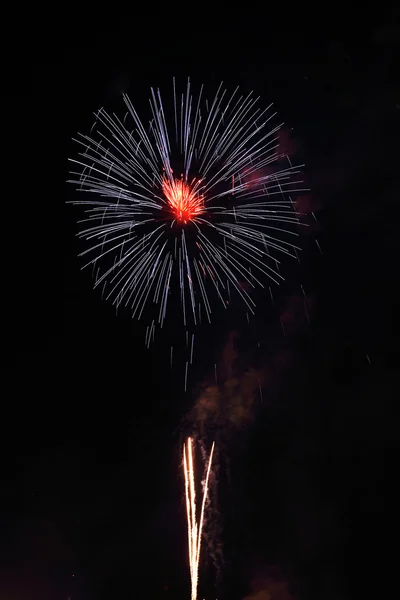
[70,80,302,352]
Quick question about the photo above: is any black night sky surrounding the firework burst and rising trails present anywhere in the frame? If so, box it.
[0,5,400,600]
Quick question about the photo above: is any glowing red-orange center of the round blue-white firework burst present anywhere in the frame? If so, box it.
[162,179,204,223]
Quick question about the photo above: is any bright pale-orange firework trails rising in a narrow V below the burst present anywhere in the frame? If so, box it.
[183,438,215,600]
